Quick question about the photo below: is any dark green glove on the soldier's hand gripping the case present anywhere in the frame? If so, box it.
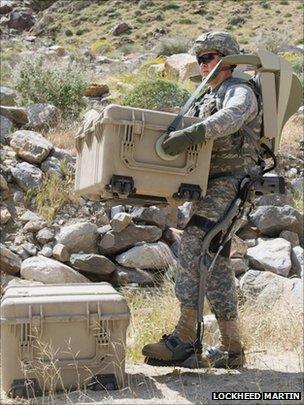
[162,122,205,156]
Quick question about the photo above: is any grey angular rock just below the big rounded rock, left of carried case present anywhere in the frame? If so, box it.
[11,162,43,191]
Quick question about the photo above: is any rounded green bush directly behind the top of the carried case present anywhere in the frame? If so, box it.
[122,79,190,110]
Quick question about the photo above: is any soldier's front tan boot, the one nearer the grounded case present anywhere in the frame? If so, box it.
[142,306,197,361]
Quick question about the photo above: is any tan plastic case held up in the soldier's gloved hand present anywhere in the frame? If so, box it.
[75,104,212,201]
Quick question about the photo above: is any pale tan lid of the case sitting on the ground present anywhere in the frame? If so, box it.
[1,282,129,321]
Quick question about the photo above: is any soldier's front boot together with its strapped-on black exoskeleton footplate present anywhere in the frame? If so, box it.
[142,306,197,366]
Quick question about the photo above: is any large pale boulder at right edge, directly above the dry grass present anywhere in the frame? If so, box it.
[240,270,303,314]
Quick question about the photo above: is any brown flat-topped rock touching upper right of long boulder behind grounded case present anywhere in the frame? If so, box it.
[70,253,116,275]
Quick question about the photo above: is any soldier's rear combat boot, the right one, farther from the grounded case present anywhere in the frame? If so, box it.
[203,320,245,368]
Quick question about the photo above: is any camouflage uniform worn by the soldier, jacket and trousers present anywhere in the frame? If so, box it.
[175,78,261,320]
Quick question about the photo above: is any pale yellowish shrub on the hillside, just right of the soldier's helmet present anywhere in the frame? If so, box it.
[253,28,290,53]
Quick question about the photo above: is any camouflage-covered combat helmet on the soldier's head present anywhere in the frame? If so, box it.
[191,31,240,56]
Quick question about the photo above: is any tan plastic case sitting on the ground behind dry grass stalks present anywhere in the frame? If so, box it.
[1,283,130,397]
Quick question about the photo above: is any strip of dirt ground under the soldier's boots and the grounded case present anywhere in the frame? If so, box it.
[1,352,303,405]
